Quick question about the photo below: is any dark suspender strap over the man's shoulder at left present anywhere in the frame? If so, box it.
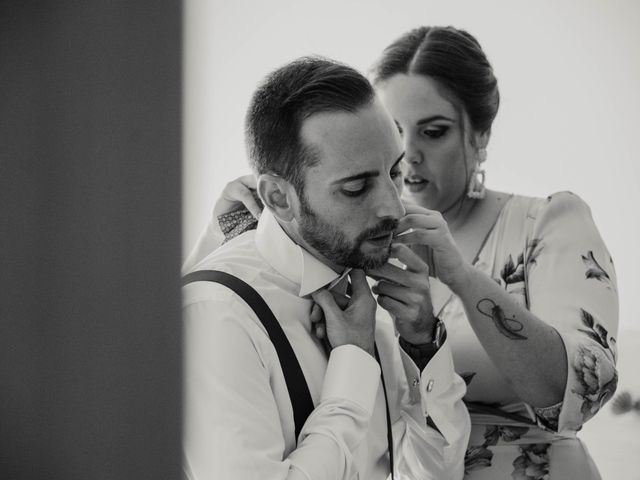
[182,270,313,441]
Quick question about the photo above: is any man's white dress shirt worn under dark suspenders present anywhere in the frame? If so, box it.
[183,210,470,480]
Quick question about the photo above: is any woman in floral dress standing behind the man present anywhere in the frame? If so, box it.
[187,27,618,480]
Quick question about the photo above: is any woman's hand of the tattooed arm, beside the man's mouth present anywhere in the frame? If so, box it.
[394,205,471,292]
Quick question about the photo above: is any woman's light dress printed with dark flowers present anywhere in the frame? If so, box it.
[433,192,618,480]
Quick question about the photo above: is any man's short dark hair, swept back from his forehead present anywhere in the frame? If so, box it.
[245,57,375,194]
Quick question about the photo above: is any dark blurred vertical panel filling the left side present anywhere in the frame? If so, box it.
[0,0,181,480]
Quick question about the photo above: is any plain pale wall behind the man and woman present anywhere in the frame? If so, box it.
[183,0,640,472]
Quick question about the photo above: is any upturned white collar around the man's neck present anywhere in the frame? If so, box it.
[255,208,351,297]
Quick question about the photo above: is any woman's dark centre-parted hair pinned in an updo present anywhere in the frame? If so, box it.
[371,27,500,133]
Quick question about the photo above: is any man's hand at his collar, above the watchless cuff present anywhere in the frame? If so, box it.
[312,270,376,355]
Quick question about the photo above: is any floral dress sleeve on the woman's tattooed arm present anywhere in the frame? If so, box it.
[525,192,618,432]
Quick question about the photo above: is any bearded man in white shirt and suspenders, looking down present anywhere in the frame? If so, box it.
[184,58,470,480]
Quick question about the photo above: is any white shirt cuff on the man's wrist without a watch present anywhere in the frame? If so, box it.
[320,345,380,414]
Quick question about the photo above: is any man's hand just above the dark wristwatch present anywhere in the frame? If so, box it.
[367,243,435,345]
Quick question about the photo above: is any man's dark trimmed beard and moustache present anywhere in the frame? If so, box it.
[299,193,398,270]
